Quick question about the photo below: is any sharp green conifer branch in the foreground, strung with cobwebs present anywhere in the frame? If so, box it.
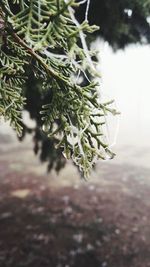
[0,0,116,177]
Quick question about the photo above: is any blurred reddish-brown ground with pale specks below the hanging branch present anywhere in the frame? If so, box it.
[0,126,150,267]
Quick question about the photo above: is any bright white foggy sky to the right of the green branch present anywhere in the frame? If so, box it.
[100,43,150,149]
